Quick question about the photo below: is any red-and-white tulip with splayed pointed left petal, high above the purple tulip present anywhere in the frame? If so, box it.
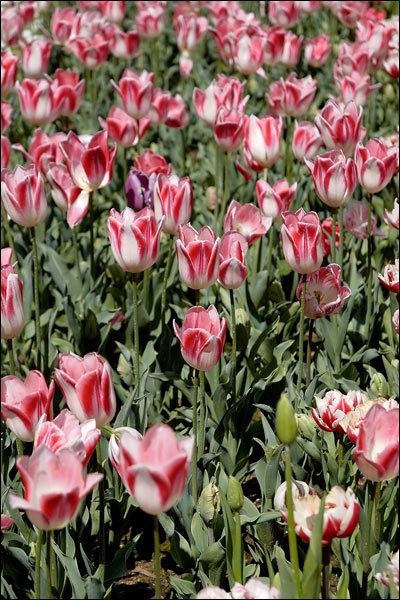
[111,69,154,119]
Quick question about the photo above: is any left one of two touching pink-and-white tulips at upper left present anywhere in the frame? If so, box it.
[16,79,65,125]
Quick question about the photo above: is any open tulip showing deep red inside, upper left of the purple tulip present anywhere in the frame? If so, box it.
[60,131,117,192]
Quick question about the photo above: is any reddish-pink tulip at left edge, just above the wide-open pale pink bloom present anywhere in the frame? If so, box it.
[1,370,54,442]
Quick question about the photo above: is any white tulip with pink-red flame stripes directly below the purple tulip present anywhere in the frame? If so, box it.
[107,207,163,273]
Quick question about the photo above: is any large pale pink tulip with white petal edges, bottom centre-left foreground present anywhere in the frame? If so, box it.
[118,424,193,515]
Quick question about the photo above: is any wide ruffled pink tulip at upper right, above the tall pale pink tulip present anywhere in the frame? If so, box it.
[267,73,317,117]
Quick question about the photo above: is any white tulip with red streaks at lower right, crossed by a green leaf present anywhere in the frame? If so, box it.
[283,486,361,546]
